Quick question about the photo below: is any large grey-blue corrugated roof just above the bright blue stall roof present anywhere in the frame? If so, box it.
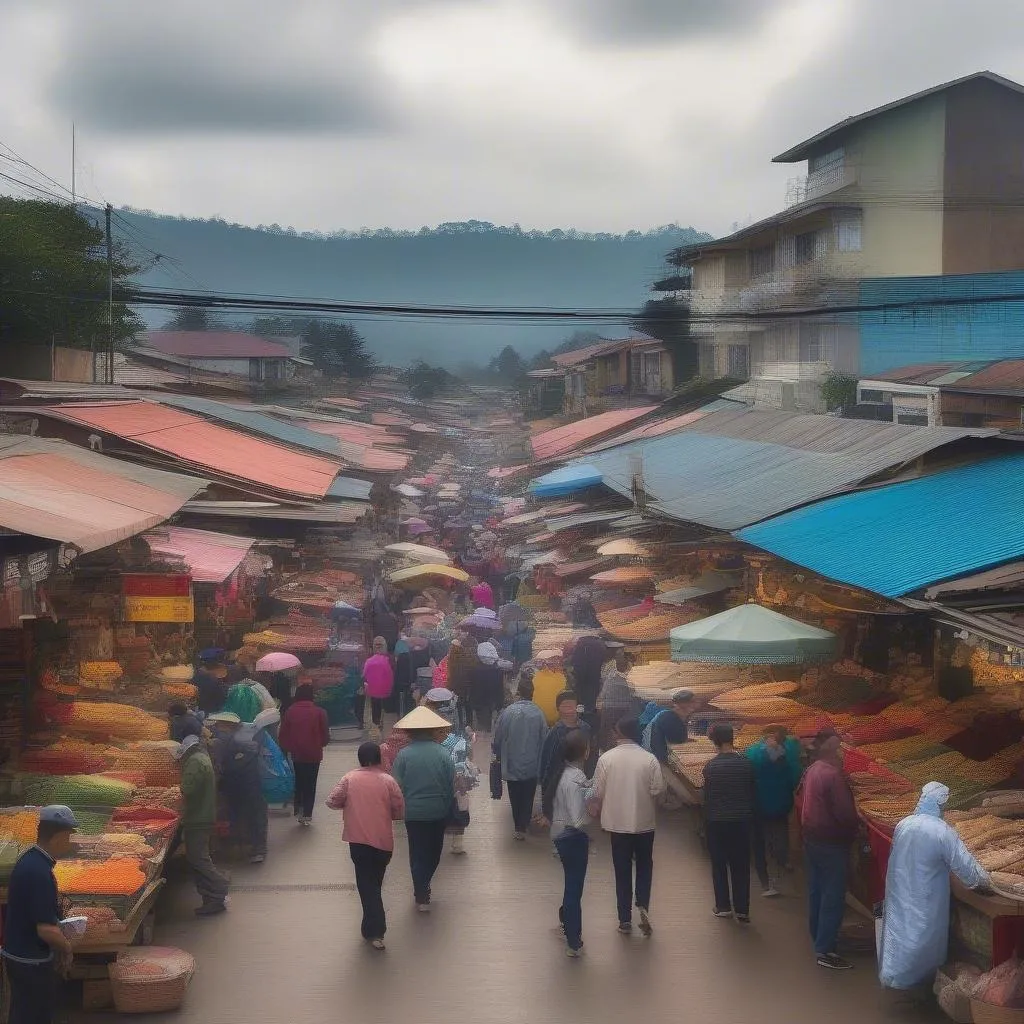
[586,409,997,530]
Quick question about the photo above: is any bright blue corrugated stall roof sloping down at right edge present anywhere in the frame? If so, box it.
[736,453,1024,597]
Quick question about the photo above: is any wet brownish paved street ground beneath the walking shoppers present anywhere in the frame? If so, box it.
[76,741,945,1024]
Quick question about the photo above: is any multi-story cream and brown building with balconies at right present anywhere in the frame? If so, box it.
[672,72,1024,410]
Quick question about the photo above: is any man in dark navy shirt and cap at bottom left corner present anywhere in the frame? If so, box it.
[3,804,78,1024]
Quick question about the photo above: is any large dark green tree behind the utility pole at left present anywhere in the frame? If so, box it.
[0,196,141,348]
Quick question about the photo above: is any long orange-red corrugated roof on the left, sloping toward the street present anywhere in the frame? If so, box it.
[29,401,341,498]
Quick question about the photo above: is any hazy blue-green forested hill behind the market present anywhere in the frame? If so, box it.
[115,210,708,367]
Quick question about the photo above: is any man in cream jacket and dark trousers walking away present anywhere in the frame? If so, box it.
[594,718,665,936]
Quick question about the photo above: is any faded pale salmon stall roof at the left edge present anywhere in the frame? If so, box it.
[0,434,209,552]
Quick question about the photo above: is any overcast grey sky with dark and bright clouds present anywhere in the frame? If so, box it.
[0,0,1024,233]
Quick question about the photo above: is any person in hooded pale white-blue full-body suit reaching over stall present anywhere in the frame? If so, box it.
[879,782,989,990]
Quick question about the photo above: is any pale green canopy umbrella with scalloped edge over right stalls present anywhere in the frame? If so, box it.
[670,604,839,665]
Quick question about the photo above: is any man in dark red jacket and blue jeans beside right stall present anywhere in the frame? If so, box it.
[800,729,860,971]
